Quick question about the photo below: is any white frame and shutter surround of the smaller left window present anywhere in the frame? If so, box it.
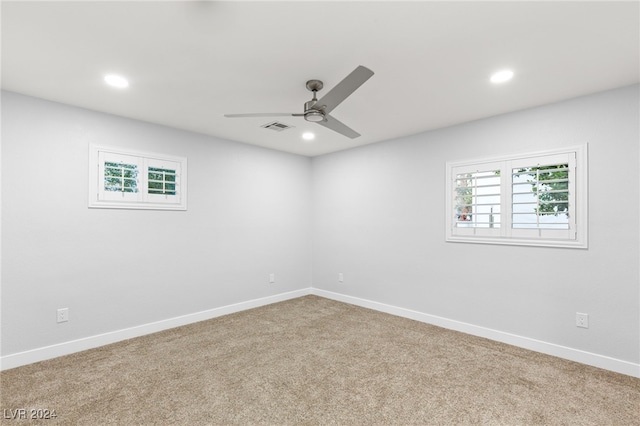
[89,144,187,210]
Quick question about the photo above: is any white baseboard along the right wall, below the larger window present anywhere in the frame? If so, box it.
[311,288,640,378]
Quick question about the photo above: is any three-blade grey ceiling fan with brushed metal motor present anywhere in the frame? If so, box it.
[224,65,373,139]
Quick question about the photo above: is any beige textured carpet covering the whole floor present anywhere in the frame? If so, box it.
[0,296,640,426]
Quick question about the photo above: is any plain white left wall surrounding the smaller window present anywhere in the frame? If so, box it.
[2,92,311,359]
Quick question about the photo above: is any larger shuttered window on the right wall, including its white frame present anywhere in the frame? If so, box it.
[446,145,587,248]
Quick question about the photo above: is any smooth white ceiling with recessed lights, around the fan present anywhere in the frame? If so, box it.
[1,1,640,156]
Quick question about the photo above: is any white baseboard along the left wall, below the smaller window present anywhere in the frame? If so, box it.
[0,288,311,370]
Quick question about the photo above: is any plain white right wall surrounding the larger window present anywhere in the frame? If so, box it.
[312,86,640,375]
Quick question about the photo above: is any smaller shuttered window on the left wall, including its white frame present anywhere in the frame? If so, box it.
[89,146,187,210]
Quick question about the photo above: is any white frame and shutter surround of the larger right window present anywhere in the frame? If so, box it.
[445,144,588,249]
